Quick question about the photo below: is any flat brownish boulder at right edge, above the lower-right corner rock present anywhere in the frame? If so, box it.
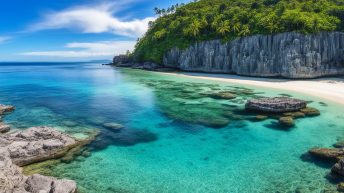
[308,148,344,162]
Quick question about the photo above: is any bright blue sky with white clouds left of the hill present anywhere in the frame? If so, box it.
[0,0,190,61]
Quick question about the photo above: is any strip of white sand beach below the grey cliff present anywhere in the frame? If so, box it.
[163,72,344,105]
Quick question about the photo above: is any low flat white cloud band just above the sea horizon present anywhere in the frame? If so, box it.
[20,41,136,58]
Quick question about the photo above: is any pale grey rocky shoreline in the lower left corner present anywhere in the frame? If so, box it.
[0,105,94,193]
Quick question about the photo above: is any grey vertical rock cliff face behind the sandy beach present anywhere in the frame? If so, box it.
[163,32,344,78]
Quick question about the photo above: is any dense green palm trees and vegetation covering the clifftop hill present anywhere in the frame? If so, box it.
[132,0,344,63]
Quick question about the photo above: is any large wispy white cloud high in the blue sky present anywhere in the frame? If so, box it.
[27,1,155,37]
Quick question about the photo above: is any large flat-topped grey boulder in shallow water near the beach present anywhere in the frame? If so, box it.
[245,97,307,113]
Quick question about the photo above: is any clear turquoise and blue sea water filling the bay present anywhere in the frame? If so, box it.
[0,63,344,193]
